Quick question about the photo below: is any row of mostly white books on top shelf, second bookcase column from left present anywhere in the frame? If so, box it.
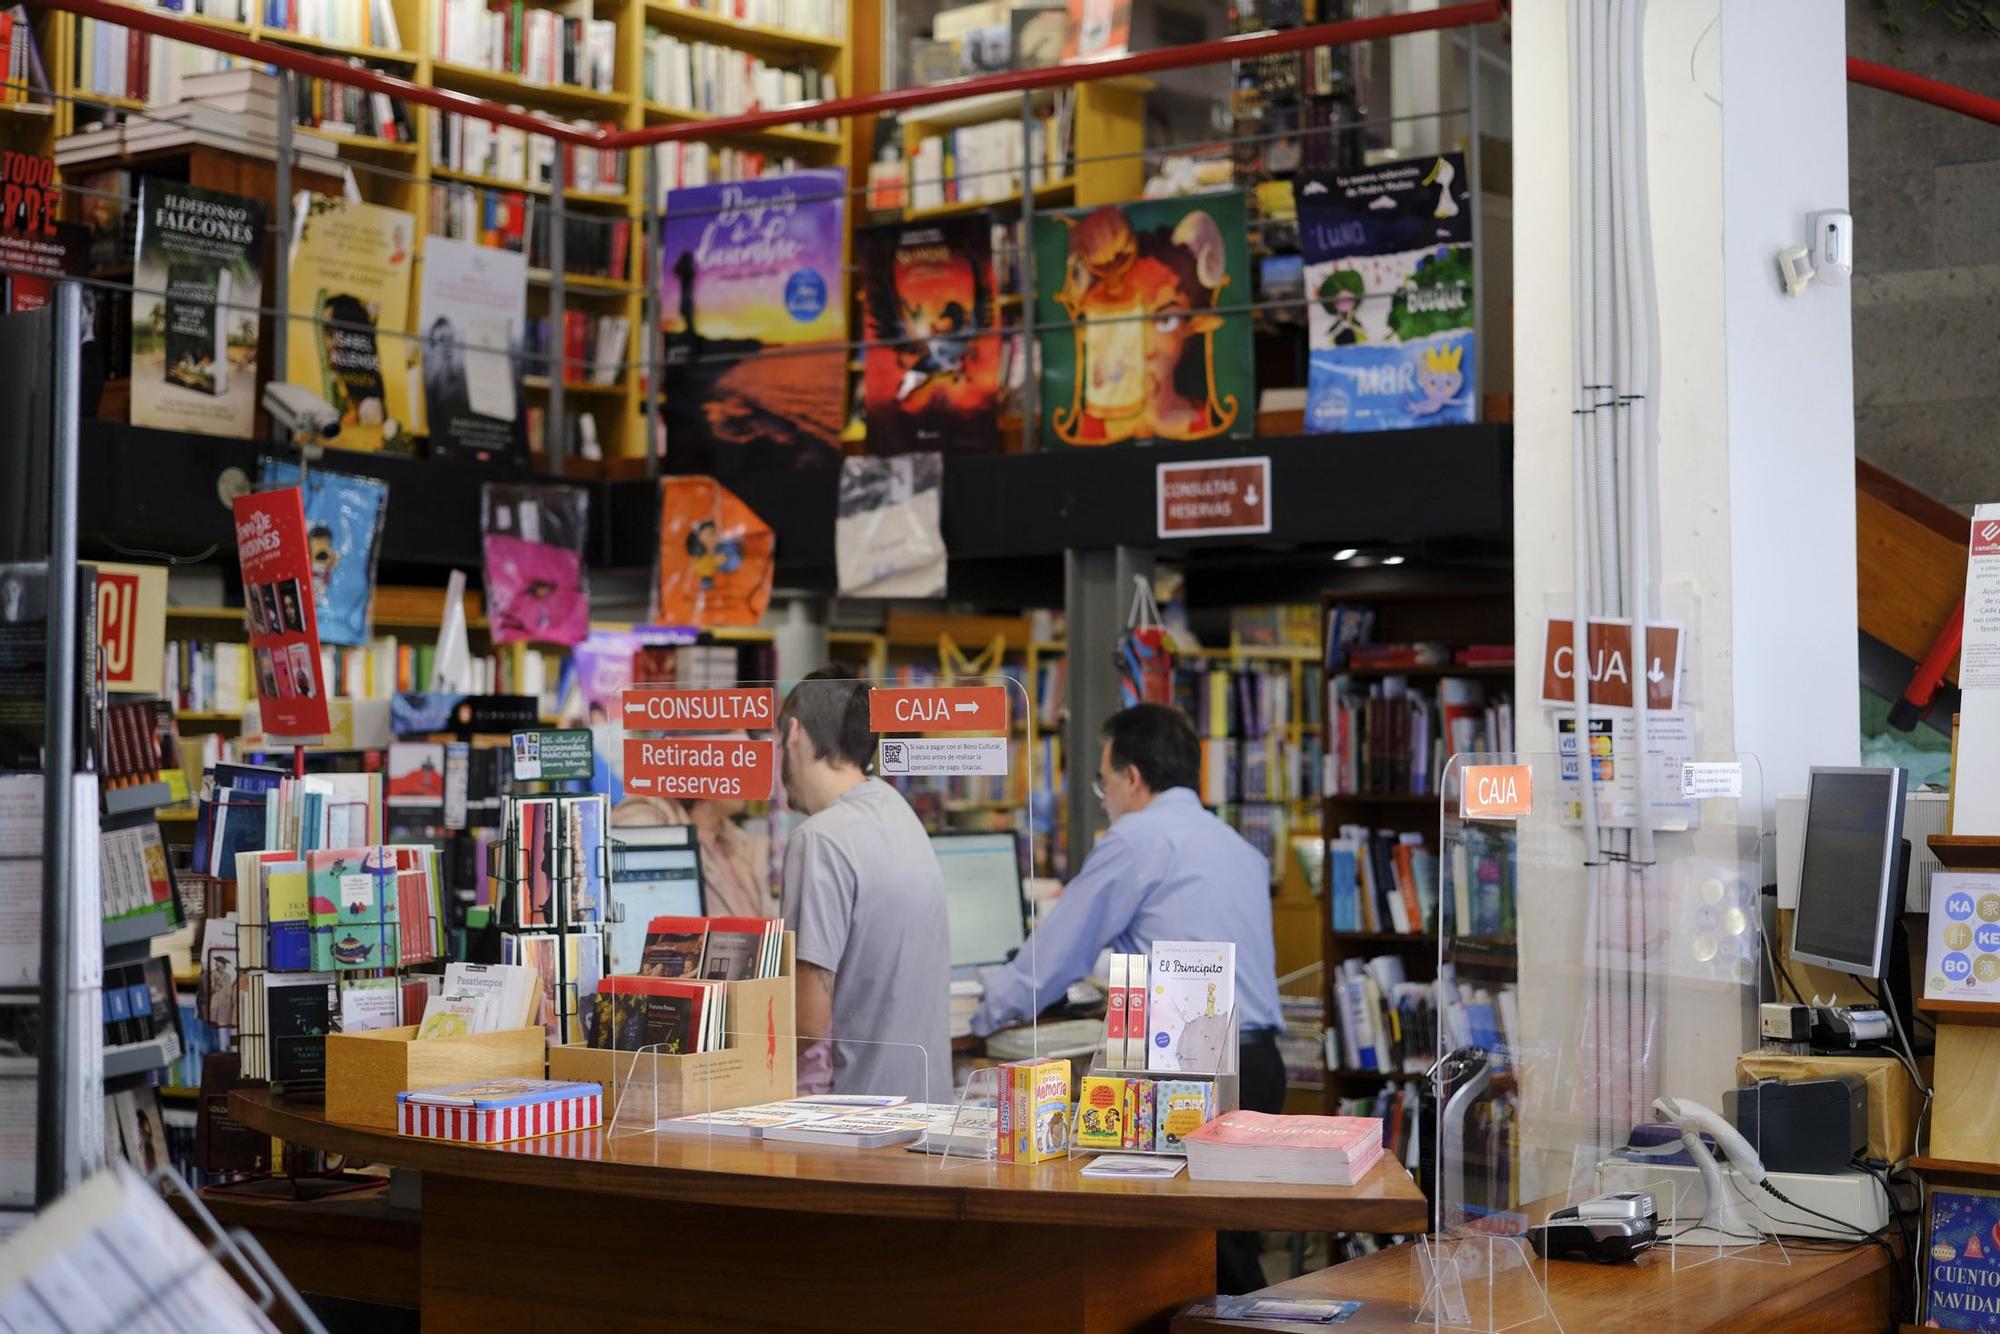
[432,0,618,92]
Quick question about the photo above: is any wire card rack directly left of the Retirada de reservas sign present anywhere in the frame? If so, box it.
[488,792,616,1046]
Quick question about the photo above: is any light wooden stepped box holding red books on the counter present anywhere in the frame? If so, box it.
[548,932,798,1126]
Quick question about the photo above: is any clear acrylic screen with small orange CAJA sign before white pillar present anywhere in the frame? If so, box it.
[1424,748,1790,1332]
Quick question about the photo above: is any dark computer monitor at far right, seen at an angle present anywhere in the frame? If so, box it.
[1792,768,1904,978]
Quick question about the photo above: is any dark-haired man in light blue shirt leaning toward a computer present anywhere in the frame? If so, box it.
[972,704,1284,1292]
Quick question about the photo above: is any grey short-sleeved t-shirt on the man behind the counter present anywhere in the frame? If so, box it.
[784,778,952,1102]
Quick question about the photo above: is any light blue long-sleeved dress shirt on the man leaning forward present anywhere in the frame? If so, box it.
[972,788,1284,1038]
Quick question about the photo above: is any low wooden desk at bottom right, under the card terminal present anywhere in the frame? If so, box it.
[1174,1246,1896,1334]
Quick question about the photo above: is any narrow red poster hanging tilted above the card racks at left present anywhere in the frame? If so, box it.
[234,486,328,740]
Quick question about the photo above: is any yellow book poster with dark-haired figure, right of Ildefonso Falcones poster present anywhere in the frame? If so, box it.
[284,192,416,450]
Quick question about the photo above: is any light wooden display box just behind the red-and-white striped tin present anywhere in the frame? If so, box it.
[326,1024,548,1130]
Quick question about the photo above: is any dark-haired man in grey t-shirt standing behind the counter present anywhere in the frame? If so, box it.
[778,668,952,1102]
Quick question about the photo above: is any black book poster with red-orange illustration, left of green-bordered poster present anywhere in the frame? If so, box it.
[854,214,1000,454]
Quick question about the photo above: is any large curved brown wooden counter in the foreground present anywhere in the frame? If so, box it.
[230,1090,1428,1334]
